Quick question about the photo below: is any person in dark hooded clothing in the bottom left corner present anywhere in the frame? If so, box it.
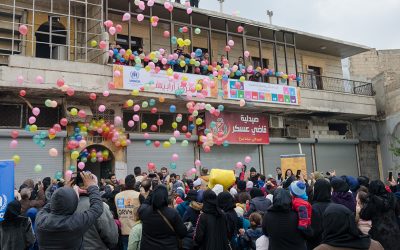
[0,200,35,250]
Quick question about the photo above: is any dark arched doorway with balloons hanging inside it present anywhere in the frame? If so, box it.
[78,145,115,181]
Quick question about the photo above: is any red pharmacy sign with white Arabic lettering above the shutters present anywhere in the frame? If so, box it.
[206,112,269,144]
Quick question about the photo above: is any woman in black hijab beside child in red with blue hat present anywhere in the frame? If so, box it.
[262,188,307,250]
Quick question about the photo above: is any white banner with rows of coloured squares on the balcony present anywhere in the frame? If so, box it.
[224,79,300,105]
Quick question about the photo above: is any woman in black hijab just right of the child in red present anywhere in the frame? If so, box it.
[307,179,332,249]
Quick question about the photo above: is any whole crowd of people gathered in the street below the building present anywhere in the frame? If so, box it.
[0,166,400,250]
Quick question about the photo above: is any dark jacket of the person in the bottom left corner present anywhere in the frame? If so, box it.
[0,216,35,250]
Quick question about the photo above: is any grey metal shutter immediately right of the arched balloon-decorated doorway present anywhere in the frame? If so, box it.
[126,141,195,174]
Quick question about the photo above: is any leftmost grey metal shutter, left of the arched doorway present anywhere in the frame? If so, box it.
[0,137,64,188]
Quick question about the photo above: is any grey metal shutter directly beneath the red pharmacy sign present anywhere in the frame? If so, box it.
[200,145,260,172]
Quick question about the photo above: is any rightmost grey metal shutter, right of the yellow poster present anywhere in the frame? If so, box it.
[315,144,358,176]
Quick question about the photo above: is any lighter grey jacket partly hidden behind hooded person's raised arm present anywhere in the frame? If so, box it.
[76,196,118,250]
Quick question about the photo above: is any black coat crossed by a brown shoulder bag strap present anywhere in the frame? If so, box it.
[139,204,187,250]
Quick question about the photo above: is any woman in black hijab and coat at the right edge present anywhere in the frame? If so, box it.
[360,180,400,249]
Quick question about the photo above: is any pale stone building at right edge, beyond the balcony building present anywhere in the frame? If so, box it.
[350,49,400,176]
